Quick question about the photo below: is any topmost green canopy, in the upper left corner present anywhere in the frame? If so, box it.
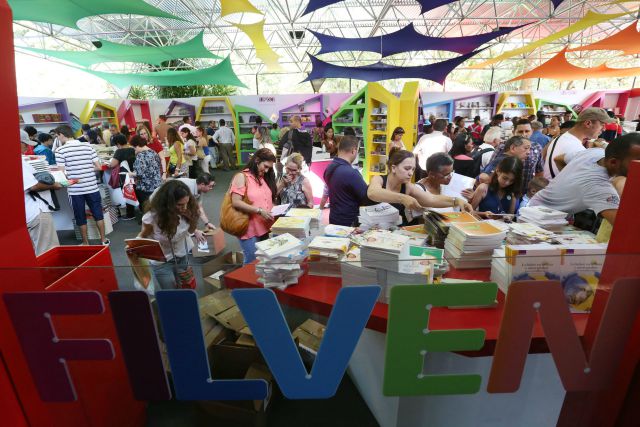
[8,0,182,28]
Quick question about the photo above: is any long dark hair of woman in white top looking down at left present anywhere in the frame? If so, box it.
[148,179,200,240]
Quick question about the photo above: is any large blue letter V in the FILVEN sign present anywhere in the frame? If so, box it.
[232,286,380,399]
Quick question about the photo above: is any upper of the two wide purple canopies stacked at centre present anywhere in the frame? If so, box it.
[309,24,523,57]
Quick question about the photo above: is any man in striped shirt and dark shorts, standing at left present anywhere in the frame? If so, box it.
[56,125,110,245]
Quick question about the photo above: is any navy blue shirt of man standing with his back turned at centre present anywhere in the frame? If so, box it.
[324,157,369,227]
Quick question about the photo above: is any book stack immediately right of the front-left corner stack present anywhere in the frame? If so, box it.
[309,236,351,277]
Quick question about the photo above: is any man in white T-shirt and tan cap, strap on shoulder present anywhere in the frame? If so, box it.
[544,107,612,181]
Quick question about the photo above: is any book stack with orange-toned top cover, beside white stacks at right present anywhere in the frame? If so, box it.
[444,222,507,269]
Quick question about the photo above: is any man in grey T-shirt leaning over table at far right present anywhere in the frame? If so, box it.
[529,133,640,224]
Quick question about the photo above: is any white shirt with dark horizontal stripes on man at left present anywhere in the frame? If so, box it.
[56,140,98,195]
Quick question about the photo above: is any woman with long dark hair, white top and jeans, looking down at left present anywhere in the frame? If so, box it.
[138,179,206,289]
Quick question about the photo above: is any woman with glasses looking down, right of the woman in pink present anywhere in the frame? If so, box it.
[277,153,313,208]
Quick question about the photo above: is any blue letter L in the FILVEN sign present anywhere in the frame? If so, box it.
[156,290,267,400]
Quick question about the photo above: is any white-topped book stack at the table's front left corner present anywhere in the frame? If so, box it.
[256,234,307,290]
